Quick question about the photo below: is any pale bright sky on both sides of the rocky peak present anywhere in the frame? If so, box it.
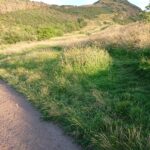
[34,0,150,9]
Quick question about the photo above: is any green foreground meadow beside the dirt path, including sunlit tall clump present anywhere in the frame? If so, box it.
[0,46,150,150]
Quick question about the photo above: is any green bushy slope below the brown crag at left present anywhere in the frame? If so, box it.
[0,7,86,44]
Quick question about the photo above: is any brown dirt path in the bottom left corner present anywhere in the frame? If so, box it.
[0,81,80,150]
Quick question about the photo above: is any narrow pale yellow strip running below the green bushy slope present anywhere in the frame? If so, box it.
[0,35,89,54]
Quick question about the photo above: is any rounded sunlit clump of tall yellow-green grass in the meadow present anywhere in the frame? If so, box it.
[61,47,111,74]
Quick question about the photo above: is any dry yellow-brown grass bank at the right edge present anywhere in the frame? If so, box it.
[92,22,150,48]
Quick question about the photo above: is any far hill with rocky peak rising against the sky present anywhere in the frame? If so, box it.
[52,0,141,23]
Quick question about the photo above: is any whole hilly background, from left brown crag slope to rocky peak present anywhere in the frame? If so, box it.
[0,0,141,44]
